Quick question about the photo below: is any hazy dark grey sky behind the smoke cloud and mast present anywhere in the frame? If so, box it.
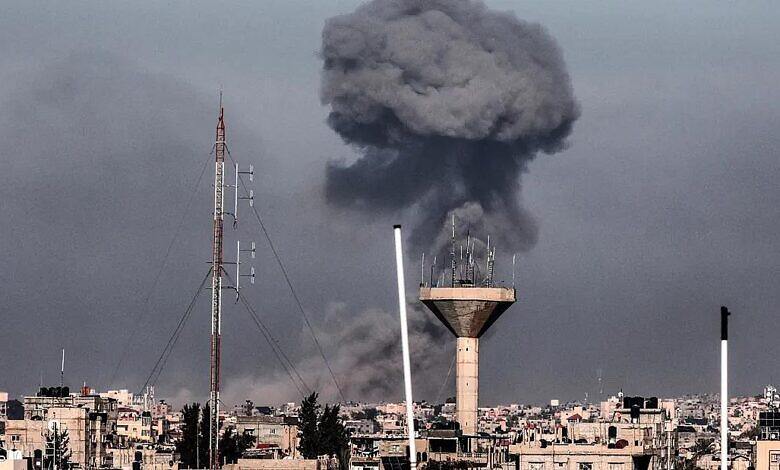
[0,1,780,403]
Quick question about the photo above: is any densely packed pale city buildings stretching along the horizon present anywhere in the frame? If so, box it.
[0,386,780,470]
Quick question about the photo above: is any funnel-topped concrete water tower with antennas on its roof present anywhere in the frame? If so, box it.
[420,223,516,435]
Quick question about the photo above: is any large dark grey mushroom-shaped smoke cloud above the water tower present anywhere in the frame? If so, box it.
[321,0,579,250]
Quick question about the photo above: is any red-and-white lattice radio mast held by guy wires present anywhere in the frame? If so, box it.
[209,102,225,470]
